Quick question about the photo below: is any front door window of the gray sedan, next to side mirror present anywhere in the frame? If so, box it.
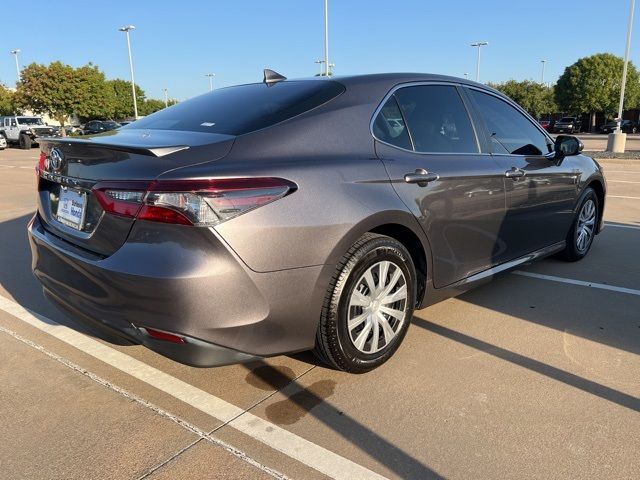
[469,89,551,155]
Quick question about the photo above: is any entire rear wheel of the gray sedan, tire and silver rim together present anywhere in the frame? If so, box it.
[314,233,416,373]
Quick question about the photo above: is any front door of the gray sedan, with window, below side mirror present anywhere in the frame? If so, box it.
[466,87,579,259]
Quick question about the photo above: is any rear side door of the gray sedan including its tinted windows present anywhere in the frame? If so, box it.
[372,84,506,288]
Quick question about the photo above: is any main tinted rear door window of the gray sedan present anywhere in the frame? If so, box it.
[395,85,478,153]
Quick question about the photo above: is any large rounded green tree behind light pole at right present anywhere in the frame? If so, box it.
[556,53,640,129]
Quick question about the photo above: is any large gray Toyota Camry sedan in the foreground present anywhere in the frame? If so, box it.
[28,71,605,372]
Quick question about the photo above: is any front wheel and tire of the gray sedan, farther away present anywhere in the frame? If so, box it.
[558,187,600,262]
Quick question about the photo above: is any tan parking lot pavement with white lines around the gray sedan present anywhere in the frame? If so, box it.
[0,148,640,479]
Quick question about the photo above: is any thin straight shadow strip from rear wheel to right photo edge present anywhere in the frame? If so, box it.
[412,317,640,412]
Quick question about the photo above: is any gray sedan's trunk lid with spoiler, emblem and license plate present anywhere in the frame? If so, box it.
[38,128,235,257]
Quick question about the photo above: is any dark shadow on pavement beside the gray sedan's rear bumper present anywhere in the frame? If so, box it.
[0,214,131,345]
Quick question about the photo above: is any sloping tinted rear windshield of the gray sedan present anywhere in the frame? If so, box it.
[122,80,345,135]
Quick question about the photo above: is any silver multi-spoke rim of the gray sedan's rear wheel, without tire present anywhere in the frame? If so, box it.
[347,260,407,354]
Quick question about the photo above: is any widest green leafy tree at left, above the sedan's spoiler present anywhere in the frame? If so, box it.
[14,62,113,135]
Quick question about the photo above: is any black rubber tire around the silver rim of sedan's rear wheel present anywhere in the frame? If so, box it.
[313,233,417,373]
